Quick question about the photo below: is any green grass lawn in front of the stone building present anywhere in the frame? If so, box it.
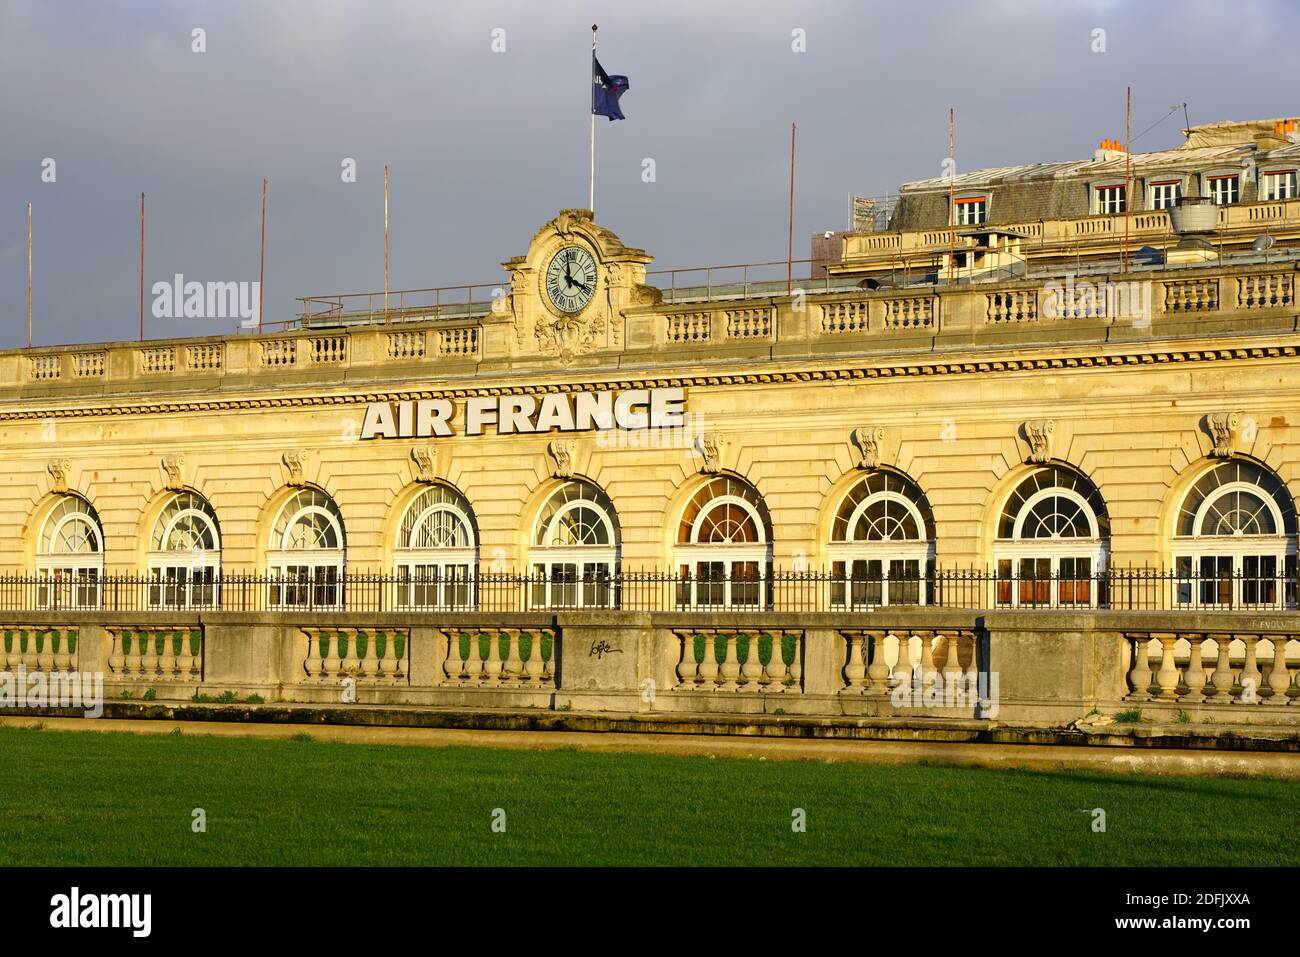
[0,727,1300,866]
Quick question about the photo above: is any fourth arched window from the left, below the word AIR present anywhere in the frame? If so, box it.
[394,485,478,609]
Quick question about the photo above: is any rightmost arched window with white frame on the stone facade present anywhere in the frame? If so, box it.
[1174,459,1296,607]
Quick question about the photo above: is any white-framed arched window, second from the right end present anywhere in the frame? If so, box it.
[993,465,1110,607]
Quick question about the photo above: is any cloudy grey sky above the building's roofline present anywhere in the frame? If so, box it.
[0,0,1300,347]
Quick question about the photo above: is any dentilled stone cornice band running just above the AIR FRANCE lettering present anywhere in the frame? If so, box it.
[0,345,1300,421]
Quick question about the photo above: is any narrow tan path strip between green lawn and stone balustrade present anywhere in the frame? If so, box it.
[10,716,1300,780]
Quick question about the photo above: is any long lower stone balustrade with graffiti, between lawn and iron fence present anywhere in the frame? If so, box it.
[0,606,1300,727]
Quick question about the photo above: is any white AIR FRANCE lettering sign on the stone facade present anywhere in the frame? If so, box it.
[361,389,686,439]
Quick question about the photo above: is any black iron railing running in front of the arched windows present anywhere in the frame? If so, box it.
[0,567,1296,612]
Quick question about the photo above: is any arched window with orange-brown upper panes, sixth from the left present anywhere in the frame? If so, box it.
[673,475,772,607]
